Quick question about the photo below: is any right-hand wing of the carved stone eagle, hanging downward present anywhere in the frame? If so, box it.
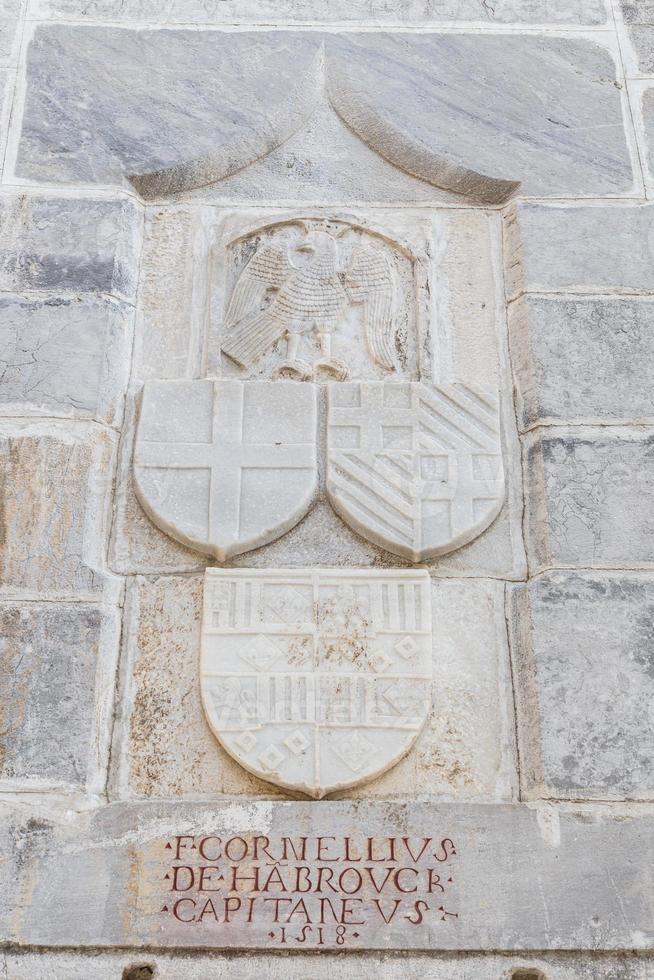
[345,245,397,371]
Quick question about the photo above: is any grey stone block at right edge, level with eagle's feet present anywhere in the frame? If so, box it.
[509,295,654,429]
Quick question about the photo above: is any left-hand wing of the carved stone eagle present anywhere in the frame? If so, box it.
[221,245,293,367]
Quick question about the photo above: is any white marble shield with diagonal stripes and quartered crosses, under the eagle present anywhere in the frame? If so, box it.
[327,382,504,561]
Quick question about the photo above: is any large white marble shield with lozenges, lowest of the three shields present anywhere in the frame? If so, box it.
[200,568,431,798]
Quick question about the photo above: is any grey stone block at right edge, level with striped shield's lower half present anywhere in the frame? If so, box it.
[525,427,654,573]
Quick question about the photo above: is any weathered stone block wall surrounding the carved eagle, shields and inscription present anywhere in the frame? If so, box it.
[0,0,654,980]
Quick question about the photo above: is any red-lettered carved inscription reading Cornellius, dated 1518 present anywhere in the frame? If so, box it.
[157,833,460,949]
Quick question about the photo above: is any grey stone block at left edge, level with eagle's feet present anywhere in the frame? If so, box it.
[0,294,132,425]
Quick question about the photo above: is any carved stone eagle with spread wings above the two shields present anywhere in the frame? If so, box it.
[222,230,397,371]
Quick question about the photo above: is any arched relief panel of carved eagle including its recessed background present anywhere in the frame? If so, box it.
[221,219,407,381]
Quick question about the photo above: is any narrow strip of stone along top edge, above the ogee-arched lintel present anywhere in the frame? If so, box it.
[25,0,606,27]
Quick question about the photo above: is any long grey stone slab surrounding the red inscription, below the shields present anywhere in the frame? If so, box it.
[2,802,653,952]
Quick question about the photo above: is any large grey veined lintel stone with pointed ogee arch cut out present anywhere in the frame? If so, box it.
[12,26,632,201]
